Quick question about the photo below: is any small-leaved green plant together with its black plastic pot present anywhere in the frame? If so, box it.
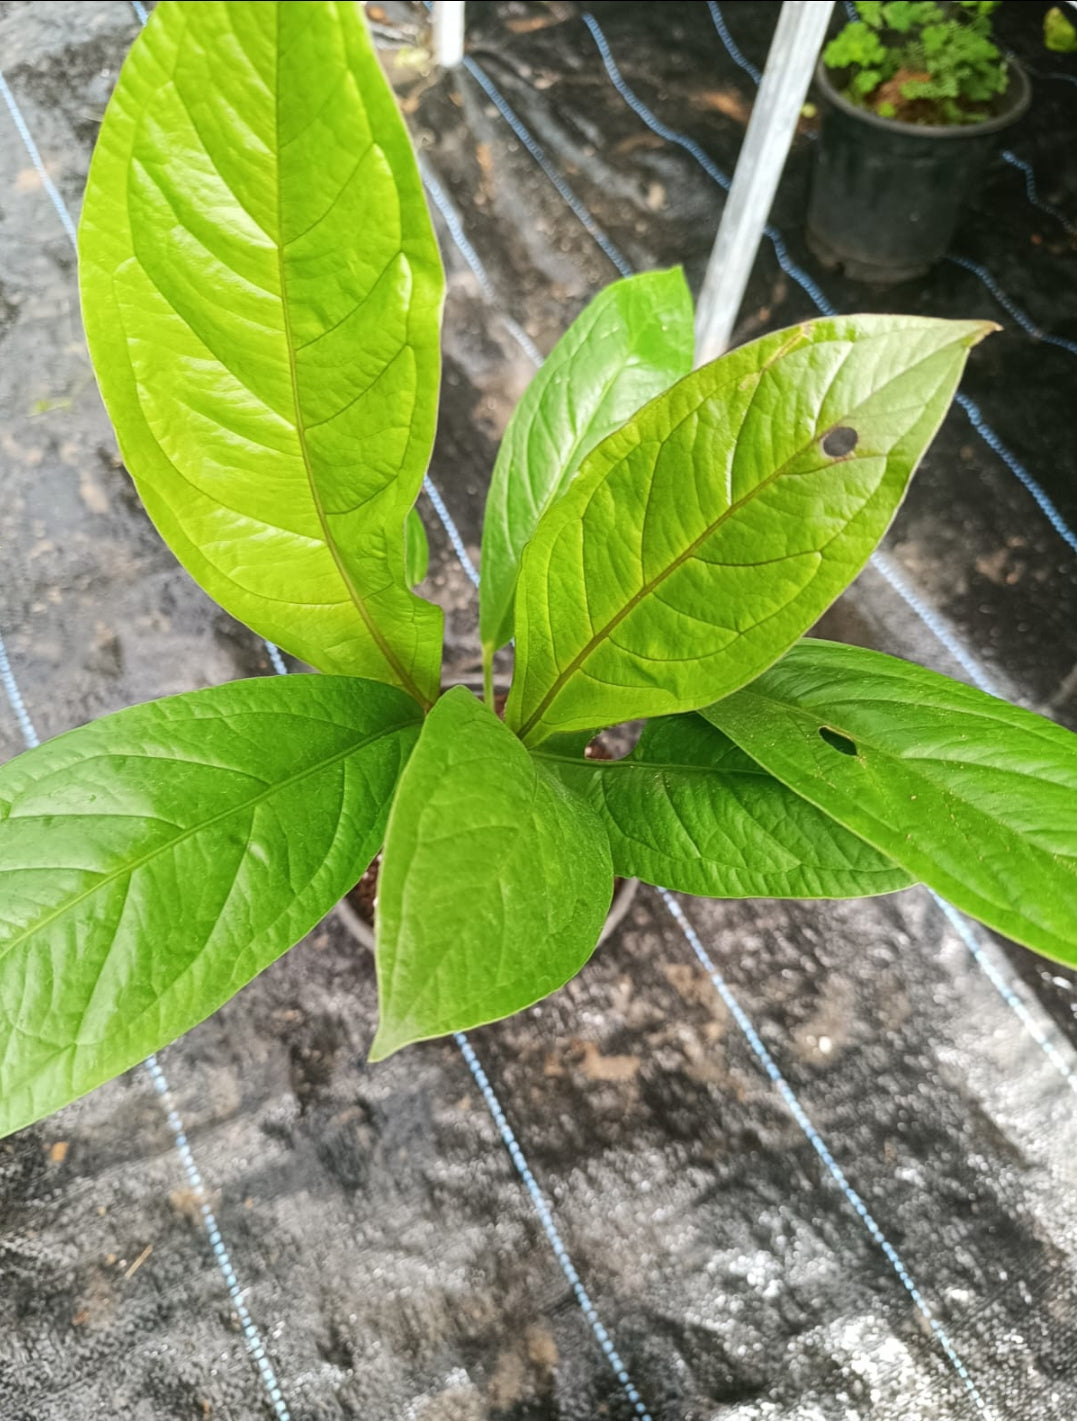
[807,0,1030,281]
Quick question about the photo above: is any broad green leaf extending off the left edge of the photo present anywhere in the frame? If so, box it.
[0,676,422,1134]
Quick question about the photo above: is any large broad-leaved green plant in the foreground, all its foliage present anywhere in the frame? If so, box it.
[0,0,1077,1131]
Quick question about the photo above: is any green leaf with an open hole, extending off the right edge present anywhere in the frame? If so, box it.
[705,641,1077,963]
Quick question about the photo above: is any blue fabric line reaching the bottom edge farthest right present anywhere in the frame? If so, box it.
[658,888,990,1417]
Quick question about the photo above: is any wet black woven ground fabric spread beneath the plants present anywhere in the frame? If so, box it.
[0,0,1077,1421]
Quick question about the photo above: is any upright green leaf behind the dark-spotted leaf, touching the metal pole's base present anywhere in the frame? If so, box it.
[479,267,695,654]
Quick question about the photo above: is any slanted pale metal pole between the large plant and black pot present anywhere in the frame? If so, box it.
[696,0,834,365]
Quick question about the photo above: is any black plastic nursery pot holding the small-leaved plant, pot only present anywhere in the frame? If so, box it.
[807,60,1032,283]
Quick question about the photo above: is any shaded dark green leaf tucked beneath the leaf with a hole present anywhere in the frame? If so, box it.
[534,715,912,898]
